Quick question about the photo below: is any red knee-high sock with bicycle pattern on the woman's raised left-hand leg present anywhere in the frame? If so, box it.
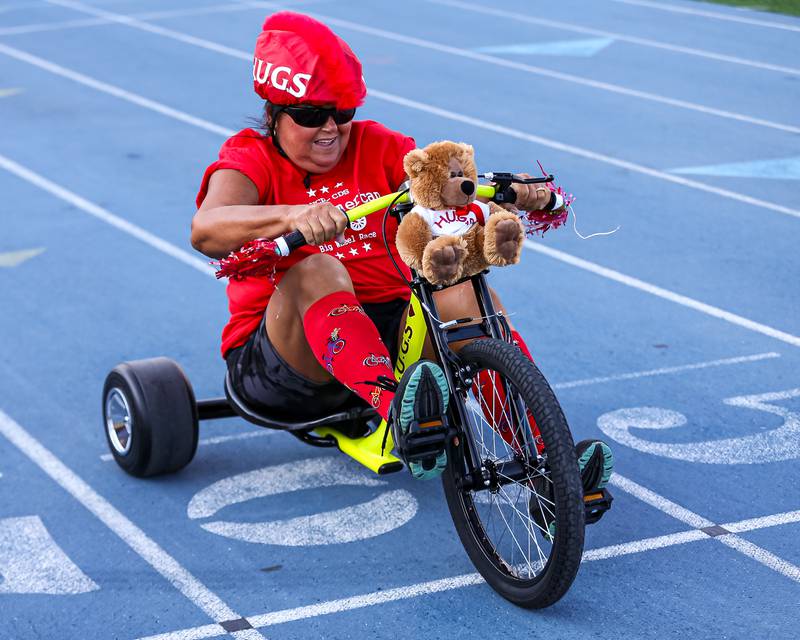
[303,291,394,418]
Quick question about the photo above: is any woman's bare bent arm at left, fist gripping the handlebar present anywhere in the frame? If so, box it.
[191,169,347,258]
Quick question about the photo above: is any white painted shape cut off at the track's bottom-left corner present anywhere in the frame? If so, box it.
[0,516,100,595]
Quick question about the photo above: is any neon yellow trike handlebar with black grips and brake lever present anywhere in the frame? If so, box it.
[275,173,564,256]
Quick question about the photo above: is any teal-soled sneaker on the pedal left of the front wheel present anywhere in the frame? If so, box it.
[389,360,450,480]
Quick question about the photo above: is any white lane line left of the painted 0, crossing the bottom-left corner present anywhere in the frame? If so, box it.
[0,410,263,640]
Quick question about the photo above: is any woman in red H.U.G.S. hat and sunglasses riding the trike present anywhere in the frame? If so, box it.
[192,12,612,488]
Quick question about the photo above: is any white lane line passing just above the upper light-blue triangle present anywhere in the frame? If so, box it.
[427,0,800,75]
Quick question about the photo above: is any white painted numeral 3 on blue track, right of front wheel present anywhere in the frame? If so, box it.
[597,388,800,464]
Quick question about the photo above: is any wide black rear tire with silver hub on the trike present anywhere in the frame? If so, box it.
[103,358,198,478]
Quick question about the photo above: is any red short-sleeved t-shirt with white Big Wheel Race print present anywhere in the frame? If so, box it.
[197,120,416,357]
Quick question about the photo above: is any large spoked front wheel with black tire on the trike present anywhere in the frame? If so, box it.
[443,339,584,608]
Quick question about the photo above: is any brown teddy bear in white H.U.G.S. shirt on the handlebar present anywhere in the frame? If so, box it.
[396,140,525,286]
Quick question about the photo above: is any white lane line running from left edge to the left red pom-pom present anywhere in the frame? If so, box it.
[0,155,215,276]
